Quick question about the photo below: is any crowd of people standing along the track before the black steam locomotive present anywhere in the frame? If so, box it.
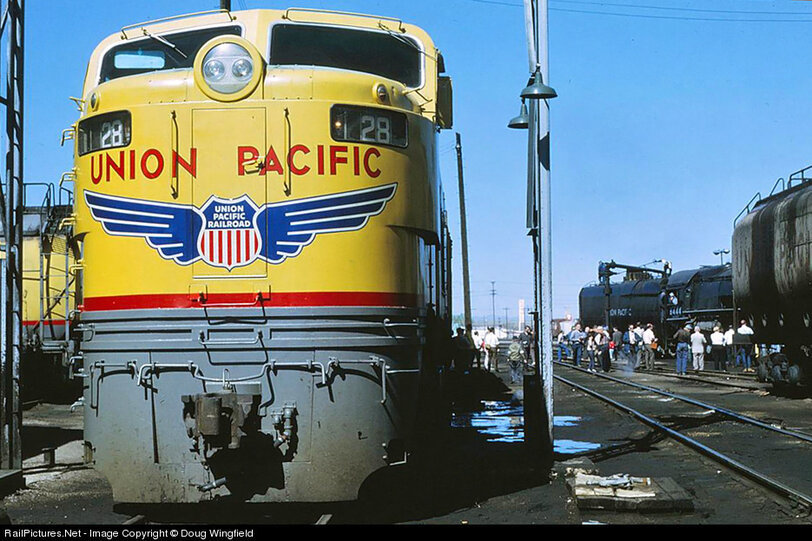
[557,320,755,374]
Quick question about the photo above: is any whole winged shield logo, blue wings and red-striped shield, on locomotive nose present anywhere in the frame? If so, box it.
[85,183,397,270]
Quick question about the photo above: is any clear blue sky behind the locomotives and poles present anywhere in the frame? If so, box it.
[25,0,812,320]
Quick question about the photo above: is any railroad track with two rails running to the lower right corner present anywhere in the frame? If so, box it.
[553,362,812,513]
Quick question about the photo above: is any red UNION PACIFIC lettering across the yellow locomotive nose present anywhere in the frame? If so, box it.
[90,144,381,184]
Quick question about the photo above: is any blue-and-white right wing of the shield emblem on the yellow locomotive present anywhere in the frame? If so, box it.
[256,183,398,263]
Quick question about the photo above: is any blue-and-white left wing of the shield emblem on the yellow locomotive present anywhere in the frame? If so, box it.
[85,191,204,265]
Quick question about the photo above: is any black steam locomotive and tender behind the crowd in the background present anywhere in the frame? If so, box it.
[578,261,734,355]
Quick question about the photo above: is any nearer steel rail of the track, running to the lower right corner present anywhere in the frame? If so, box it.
[553,375,812,509]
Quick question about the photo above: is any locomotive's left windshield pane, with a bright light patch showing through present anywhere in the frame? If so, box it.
[99,26,242,83]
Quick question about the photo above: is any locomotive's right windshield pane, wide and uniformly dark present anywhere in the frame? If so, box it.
[270,24,421,88]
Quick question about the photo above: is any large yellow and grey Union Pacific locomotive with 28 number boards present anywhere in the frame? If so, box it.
[74,9,451,503]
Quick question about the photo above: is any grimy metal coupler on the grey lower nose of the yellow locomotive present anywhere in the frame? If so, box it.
[181,383,262,449]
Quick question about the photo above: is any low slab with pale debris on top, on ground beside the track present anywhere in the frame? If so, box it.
[567,473,694,512]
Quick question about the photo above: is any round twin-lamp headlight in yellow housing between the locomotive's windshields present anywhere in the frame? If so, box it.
[194,35,264,101]
